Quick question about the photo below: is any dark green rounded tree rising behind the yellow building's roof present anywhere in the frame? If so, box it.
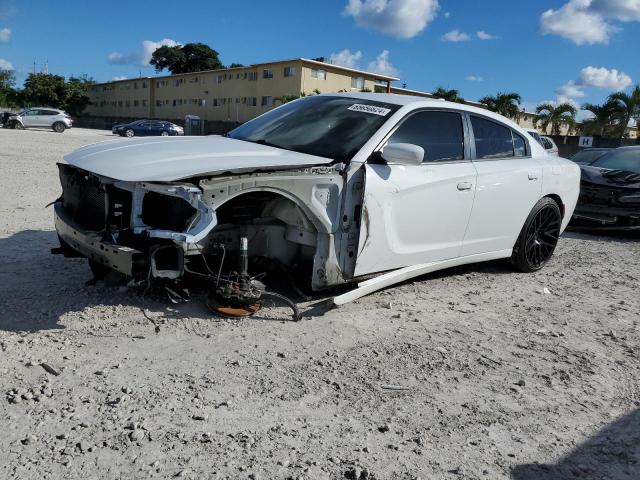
[149,43,224,75]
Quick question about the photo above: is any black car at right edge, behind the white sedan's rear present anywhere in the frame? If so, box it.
[573,146,640,230]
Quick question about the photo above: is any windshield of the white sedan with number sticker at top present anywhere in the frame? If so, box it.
[228,95,400,161]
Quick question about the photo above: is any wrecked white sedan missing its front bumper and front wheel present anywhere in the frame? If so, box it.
[55,93,580,314]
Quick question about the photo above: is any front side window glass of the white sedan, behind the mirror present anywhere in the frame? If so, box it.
[387,111,464,162]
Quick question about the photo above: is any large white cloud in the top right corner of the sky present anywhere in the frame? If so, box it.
[540,0,640,45]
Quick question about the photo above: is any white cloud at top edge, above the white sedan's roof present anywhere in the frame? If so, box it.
[343,0,438,38]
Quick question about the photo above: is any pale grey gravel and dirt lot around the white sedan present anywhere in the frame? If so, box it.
[0,129,640,480]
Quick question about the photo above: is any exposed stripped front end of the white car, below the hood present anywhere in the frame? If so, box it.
[54,163,357,318]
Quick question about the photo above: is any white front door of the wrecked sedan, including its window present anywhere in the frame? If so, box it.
[354,109,476,275]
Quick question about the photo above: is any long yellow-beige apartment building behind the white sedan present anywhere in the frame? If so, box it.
[84,58,398,123]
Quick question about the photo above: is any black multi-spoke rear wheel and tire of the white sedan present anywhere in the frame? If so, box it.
[511,197,562,273]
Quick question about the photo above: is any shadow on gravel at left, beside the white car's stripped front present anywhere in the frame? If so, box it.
[0,230,215,332]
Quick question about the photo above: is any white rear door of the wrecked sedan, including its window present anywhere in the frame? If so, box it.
[462,114,542,255]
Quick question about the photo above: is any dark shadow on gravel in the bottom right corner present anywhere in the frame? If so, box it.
[511,409,640,480]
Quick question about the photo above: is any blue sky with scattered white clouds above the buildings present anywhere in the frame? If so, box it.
[0,0,640,114]
